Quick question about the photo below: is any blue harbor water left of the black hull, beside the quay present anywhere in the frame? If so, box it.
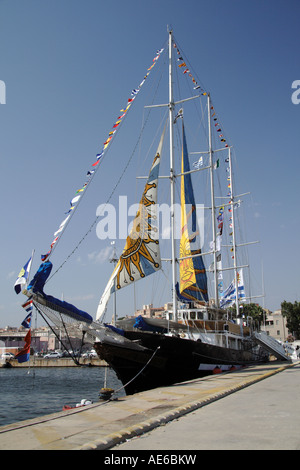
[0,367,125,426]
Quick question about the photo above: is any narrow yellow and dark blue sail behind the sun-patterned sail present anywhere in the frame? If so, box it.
[179,126,208,301]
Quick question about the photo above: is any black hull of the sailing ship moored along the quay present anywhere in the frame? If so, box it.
[94,331,267,395]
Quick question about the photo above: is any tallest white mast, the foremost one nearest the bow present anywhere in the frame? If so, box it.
[169,30,177,321]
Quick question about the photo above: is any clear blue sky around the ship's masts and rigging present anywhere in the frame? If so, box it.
[0,0,300,327]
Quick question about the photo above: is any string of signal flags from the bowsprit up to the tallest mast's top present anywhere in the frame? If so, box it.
[41,49,164,262]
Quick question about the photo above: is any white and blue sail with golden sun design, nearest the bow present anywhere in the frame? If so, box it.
[96,126,165,320]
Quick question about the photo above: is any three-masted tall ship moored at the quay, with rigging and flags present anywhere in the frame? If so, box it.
[20,31,287,394]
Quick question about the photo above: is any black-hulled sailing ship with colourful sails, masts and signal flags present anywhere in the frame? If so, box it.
[17,31,287,394]
